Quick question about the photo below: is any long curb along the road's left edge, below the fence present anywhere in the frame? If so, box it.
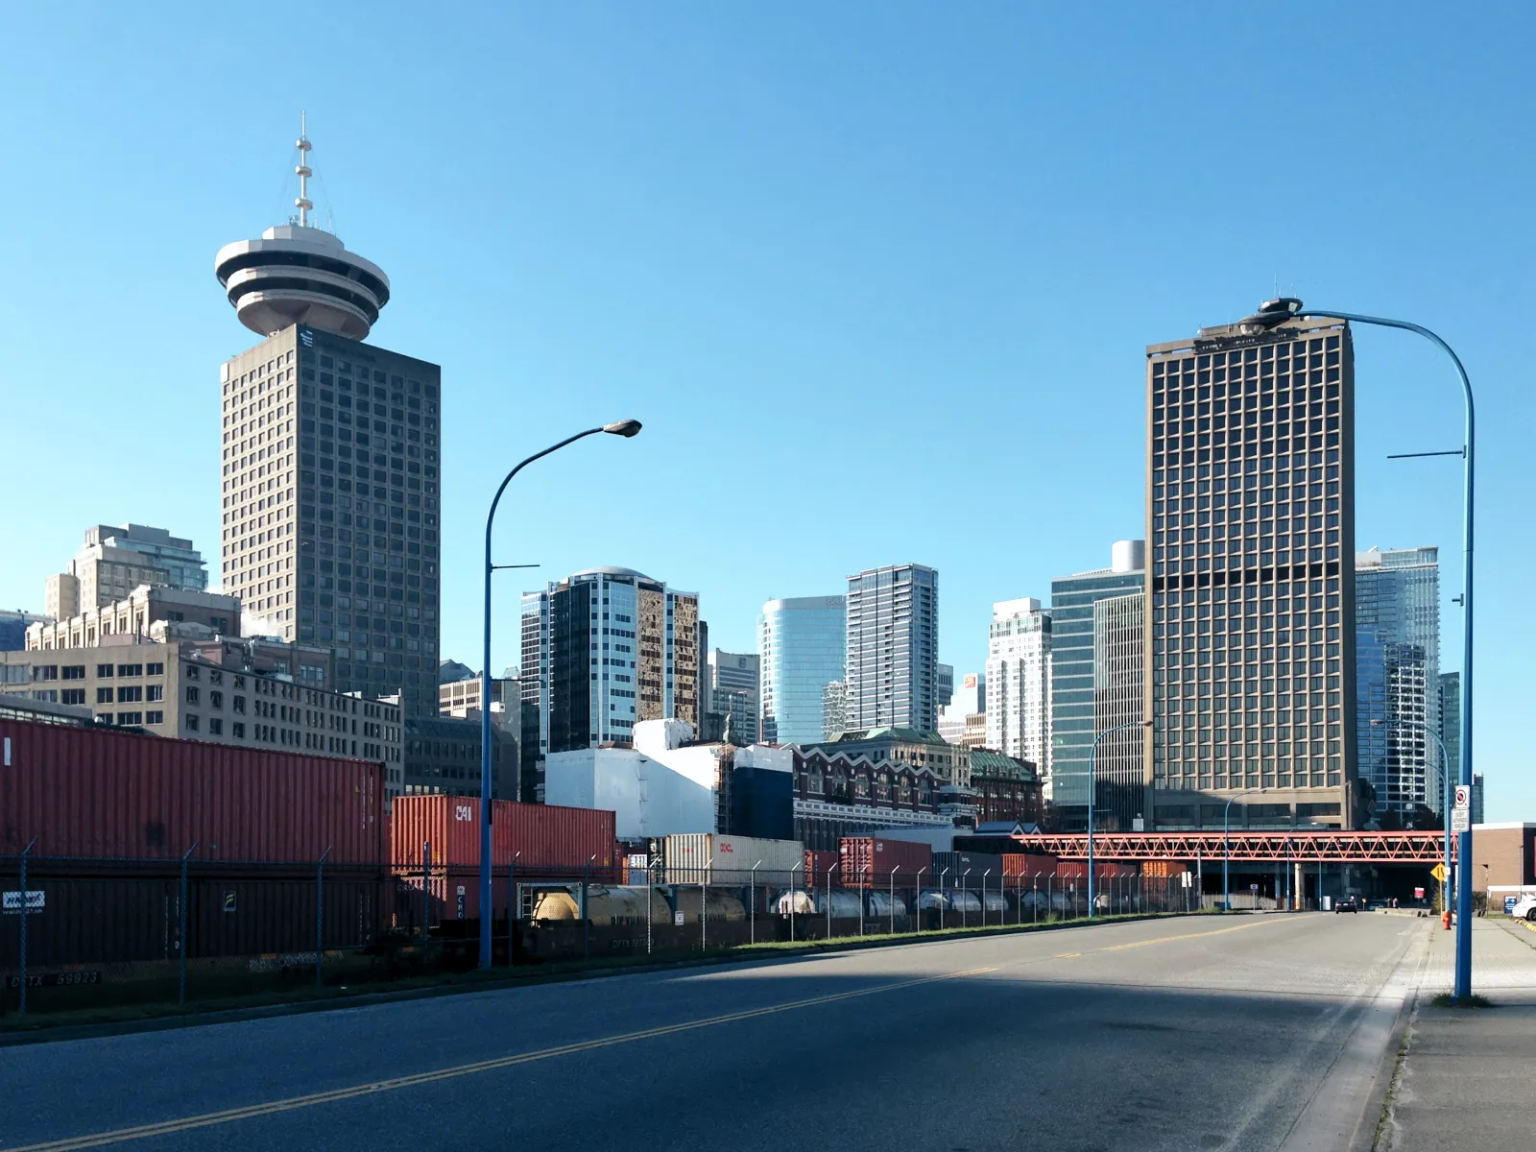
[0,912,1198,1048]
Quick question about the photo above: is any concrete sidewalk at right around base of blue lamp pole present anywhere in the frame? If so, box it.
[1376,919,1536,1152]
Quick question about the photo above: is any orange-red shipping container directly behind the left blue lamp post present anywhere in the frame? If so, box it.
[390,796,621,883]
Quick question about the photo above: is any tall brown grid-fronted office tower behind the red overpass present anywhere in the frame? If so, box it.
[1144,311,1356,828]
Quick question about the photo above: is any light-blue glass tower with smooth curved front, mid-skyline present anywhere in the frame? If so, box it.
[757,596,848,743]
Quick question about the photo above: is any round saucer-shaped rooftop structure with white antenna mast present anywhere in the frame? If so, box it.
[214,117,389,339]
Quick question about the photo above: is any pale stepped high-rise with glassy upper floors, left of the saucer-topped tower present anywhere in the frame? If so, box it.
[43,524,207,619]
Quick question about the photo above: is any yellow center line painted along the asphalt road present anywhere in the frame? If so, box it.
[0,920,1284,1152]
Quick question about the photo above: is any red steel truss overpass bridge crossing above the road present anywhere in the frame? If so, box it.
[1012,831,1456,865]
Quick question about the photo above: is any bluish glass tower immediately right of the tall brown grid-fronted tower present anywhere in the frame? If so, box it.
[1355,548,1444,817]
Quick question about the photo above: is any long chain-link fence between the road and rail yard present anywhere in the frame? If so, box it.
[0,846,1200,1017]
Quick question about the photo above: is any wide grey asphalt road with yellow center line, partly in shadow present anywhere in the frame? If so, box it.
[0,914,1428,1152]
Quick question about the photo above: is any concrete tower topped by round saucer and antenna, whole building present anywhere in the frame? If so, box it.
[215,128,442,717]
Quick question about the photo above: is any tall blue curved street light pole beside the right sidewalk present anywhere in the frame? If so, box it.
[1241,298,1476,1000]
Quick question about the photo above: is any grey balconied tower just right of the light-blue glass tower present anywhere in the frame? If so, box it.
[845,564,938,733]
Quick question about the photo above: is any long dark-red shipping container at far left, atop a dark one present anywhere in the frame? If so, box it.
[0,720,387,865]
